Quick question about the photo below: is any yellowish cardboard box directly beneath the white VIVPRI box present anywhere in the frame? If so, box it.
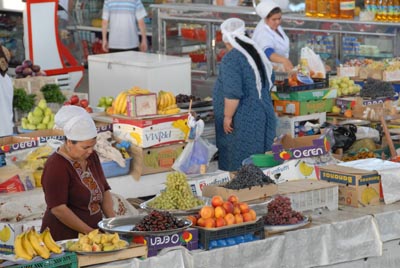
[130,142,186,180]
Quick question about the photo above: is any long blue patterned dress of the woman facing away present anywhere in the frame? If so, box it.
[213,49,276,171]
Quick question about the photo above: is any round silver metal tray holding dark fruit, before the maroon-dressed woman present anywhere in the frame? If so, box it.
[98,216,192,236]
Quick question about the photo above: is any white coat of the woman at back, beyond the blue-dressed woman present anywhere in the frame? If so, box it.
[252,19,290,68]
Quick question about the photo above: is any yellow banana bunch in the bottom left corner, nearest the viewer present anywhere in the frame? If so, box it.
[14,228,63,261]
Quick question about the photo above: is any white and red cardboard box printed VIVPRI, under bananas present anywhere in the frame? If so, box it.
[113,113,189,148]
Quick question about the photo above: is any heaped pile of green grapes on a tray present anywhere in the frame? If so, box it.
[148,172,204,210]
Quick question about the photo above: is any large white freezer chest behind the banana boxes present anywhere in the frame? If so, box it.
[88,51,191,105]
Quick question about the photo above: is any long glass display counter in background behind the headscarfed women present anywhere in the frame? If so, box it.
[151,4,400,96]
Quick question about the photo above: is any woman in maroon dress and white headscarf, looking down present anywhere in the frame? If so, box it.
[41,106,115,241]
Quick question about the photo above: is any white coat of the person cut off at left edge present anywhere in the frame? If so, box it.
[0,74,14,137]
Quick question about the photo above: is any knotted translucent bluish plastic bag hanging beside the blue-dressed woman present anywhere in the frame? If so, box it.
[172,115,217,174]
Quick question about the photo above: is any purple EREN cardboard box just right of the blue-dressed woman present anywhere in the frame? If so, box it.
[272,135,331,161]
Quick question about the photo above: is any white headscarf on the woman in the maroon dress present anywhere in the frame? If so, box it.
[54,105,97,141]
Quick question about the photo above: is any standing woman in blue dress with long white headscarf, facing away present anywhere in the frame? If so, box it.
[213,18,276,171]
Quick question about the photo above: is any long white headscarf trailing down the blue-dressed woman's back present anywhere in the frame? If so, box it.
[221,18,272,99]
